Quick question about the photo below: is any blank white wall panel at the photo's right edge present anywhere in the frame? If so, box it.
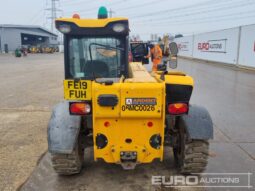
[238,25,255,67]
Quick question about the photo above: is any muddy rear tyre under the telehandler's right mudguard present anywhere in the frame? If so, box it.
[173,119,209,174]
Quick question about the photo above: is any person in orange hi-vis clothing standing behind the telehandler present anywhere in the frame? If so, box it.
[146,44,162,71]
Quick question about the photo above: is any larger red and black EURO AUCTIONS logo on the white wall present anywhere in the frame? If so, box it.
[197,39,227,53]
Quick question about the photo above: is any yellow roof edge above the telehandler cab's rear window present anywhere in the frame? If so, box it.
[56,18,128,28]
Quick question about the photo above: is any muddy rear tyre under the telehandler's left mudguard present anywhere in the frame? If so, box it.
[51,137,84,175]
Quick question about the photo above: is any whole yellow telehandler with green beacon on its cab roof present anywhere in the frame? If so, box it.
[48,8,213,175]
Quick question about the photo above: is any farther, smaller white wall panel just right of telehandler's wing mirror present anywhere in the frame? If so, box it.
[174,36,193,57]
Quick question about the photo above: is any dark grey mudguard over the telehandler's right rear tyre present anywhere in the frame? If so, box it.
[181,105,213,140]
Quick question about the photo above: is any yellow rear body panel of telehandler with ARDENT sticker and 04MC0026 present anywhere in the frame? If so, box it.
[92,82,165,163]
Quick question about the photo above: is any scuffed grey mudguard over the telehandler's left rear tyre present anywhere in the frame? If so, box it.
[48,101,81,154]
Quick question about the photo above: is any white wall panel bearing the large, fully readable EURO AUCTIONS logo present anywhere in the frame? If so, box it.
[193,27,239,64]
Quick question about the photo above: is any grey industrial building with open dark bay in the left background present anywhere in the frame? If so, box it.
[0,25,58,53]
